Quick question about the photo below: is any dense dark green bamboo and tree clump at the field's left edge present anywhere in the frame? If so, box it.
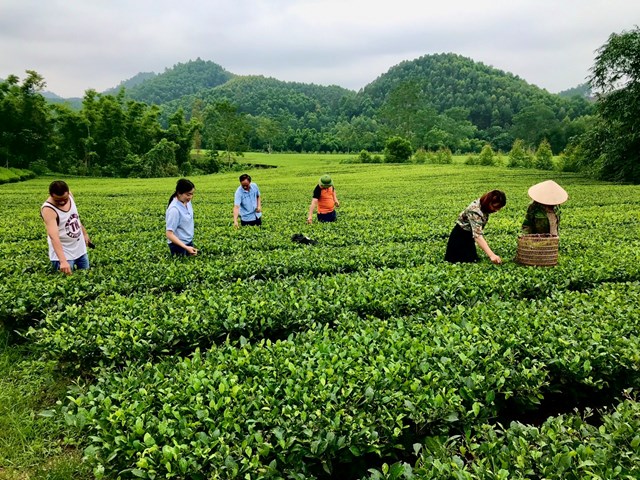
[0,74,196,177]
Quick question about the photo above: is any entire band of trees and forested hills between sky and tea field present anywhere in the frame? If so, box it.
[0,27,640,183]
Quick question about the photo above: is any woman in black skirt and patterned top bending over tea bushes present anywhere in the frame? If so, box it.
[444,190,507,264]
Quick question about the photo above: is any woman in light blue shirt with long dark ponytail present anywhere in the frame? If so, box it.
[165,178,198,255]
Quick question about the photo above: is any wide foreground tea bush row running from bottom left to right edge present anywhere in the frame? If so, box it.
[62,283,640,478]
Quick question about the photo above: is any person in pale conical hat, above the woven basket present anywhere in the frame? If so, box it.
[522,180,569,236]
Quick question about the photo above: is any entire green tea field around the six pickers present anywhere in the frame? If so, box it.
[0,154,640,479]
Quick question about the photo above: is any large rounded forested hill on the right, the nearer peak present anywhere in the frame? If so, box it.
[361,53,590,130]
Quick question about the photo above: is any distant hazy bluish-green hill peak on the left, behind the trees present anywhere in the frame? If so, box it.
[116,58,234,105]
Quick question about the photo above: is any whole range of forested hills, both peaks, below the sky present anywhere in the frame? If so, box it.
[36,53,593,153]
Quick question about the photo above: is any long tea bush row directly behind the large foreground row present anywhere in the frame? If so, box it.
[32,249,640,368]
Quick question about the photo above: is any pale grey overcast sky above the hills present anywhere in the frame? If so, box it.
[0,0,640,97]
